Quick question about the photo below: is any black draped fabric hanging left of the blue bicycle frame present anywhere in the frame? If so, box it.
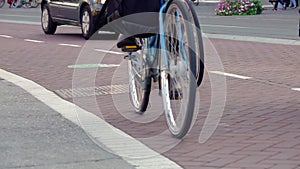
[106,0,161,36]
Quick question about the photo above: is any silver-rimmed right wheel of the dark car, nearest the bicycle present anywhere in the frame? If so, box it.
[80,6,94,39]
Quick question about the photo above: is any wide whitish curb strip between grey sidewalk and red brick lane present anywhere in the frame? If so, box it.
[0,69,182,169]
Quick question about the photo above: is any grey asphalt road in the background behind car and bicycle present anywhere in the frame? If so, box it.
[0,2,300,39]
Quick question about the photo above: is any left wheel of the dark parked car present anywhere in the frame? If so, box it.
[41,4,57,34]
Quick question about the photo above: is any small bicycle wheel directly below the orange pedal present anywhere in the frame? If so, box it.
[128,46,151,114]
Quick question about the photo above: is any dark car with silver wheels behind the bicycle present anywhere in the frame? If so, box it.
[41,0,105,39]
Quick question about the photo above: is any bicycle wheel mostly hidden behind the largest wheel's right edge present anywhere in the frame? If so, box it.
[187,1,204,87]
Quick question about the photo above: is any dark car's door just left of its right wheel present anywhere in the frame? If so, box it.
[60,0,79,22]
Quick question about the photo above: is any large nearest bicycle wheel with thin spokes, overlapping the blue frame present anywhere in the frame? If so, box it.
[161,0,197,138]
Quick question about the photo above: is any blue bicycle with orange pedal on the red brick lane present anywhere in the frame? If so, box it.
[116,0,204,138]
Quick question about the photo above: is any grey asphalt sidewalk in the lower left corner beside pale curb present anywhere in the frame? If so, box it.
[0,79,134,169]
